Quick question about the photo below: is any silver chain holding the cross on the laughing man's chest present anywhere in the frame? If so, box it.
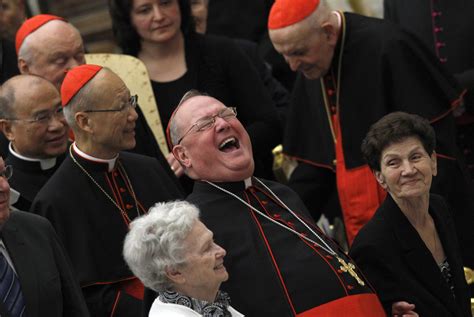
[206,177,337,256]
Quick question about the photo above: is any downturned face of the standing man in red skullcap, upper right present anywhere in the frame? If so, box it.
[269,22,337,79]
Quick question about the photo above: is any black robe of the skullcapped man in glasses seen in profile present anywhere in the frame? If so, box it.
[31,152,182,286]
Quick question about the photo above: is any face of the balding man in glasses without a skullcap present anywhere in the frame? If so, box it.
[4,79,68,158]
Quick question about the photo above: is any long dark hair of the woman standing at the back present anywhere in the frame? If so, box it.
[108,0,195,56]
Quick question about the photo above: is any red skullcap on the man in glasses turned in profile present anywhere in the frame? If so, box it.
[61,64,102,107]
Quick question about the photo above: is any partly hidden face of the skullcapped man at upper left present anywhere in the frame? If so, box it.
[18,20,85,90]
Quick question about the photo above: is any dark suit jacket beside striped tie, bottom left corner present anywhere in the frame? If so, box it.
[1,211,89,317]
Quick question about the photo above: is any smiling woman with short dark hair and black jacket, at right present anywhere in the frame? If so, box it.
[350,112,470,317]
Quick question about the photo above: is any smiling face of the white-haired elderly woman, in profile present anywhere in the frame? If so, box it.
[179,221,229,300]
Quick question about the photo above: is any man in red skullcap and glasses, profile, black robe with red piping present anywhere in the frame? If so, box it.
[32,65,181,316]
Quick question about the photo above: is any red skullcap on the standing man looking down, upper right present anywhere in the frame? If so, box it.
[268,0,319,30]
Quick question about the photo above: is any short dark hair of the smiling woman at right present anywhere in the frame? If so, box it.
[361,112,436,171]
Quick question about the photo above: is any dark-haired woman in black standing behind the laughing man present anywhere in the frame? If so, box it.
[109,0,281,190]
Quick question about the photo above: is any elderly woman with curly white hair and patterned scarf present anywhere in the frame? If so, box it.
[123,201,243,317]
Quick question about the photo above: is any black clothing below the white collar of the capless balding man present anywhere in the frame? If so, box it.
[5,154,66,210]
